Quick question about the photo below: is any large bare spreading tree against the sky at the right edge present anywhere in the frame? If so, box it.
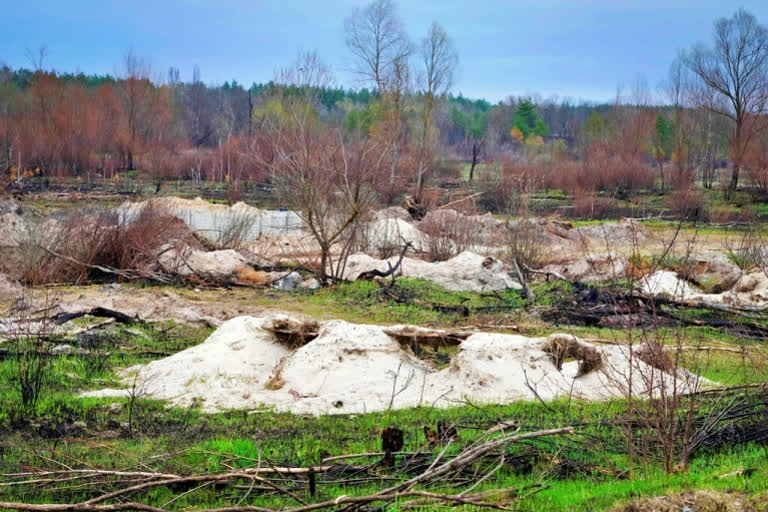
[686,9,768,191]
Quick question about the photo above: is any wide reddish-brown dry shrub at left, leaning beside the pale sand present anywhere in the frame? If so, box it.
[24,203,194,284]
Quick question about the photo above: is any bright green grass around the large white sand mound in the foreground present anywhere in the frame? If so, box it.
[0,279,768,511]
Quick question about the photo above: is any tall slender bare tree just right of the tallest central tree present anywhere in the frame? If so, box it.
[415,22,458,203]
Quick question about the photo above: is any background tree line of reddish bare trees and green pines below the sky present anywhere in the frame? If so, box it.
[0,4,768,205]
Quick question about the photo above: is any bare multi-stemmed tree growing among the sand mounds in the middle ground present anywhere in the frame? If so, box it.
[265,53,388,284]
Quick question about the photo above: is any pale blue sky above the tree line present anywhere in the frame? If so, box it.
[0,0,768,102]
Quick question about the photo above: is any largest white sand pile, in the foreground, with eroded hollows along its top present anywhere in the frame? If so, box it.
[88,317,696,414]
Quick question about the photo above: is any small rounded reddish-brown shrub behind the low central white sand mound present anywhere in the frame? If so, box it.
[419,210,477,261]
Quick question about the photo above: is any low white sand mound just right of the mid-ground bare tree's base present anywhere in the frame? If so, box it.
[344,251,522,292]
